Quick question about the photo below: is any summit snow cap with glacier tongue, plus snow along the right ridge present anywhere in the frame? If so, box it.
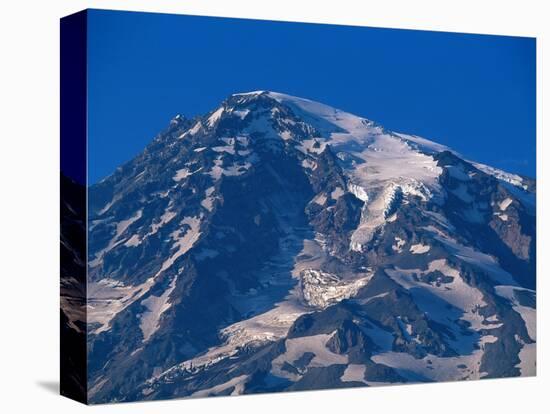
[267,92,534,251]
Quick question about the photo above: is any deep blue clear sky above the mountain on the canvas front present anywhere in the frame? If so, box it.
[88,10,536,183]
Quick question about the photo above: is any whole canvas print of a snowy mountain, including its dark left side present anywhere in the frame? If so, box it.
[61,10,536,404]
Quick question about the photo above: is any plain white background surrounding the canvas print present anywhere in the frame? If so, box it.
[0,0,550,414]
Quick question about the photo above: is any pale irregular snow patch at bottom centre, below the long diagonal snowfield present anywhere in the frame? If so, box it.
[271,332,348,381]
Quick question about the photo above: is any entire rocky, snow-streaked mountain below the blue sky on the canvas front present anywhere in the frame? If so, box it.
[78,91,536,403]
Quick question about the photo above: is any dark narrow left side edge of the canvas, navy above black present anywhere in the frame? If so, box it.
[60,11,87,403]
